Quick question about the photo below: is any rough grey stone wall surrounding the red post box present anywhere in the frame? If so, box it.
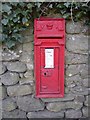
[0,21,90,118]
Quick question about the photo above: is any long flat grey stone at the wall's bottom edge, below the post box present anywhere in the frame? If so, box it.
[27,110,64,118]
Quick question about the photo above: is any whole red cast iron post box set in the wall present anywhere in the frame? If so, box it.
[34,18,65,98]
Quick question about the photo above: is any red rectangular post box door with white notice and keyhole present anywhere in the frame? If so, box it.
[40,47,59,93]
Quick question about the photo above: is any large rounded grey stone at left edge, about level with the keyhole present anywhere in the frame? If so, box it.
[1,72,19,85]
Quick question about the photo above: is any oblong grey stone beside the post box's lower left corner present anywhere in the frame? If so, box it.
[7,85,32,96]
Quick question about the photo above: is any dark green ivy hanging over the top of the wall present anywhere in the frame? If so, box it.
[0,2,90,49]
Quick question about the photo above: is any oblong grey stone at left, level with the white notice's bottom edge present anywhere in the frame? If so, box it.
[7,62,26,72]
